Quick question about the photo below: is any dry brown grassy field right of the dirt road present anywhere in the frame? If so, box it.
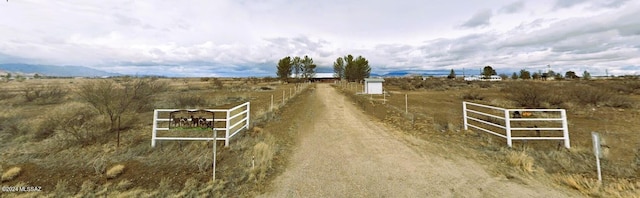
[336,78,640,197]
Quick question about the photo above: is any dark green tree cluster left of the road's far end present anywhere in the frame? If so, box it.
[276,55,317,82]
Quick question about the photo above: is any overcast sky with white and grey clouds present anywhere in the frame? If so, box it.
[0,0,640,76]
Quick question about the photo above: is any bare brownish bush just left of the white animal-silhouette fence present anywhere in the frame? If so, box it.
[78,78,167,146]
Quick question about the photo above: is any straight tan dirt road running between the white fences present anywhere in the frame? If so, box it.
[261,84,579,197]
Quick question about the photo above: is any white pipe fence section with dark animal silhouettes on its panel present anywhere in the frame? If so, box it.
[151,102,251,147]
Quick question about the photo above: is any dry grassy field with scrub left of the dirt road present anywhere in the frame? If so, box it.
[0,78,313,197]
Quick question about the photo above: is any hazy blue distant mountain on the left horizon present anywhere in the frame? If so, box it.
[0,63,122,77]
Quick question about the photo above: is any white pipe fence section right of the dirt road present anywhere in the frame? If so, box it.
[462,102,571,148]
